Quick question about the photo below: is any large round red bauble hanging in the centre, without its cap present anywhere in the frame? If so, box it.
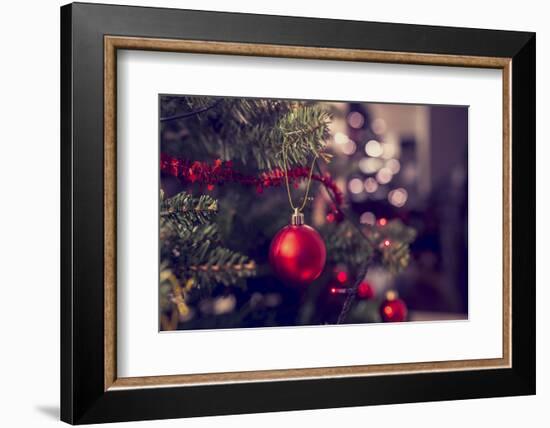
[269,224,327,285]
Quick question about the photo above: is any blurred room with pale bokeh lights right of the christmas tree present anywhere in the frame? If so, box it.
[331,103,468,320]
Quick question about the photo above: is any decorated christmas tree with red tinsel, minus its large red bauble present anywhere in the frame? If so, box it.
[159,95,415,330]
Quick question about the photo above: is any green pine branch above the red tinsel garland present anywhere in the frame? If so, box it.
[161,97,330,170]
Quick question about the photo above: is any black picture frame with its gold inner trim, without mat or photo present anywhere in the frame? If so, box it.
[61,3,536,424]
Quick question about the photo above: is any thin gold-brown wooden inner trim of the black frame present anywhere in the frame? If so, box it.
[104,36,512,391]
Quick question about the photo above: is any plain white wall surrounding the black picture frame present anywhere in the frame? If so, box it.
[0,0,550,428]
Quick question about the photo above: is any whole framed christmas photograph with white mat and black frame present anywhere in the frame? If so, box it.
[61,3,535,424]
